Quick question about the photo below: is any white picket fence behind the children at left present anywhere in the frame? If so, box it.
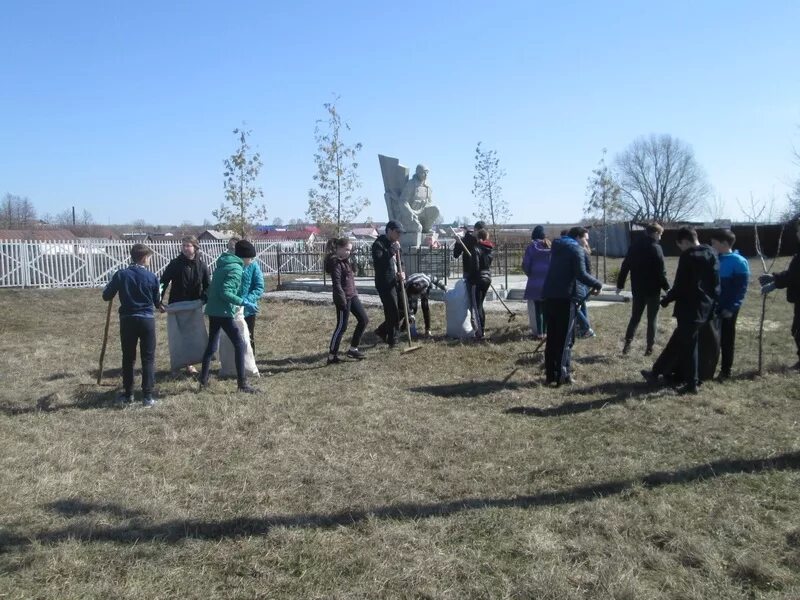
[0,239,332,288]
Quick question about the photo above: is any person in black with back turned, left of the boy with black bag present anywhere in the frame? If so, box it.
[617,223,669,356]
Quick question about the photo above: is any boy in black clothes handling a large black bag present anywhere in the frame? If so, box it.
[642,227,720,394]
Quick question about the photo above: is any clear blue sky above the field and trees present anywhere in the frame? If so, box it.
[0,0,800,223]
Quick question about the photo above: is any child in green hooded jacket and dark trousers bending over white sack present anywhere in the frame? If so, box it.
[200,240,258,394]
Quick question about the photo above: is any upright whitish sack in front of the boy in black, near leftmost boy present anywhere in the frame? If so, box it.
[167,300,208,371]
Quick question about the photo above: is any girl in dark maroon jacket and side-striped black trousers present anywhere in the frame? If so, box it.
[325,238,369,365]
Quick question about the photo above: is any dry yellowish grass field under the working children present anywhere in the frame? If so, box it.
[0,260,800,600]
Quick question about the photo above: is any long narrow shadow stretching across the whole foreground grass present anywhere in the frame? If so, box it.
[0,452,800,552]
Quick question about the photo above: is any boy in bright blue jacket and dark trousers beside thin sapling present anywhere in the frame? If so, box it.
[711,229,750,380]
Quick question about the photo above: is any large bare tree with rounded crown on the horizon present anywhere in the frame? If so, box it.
[616,134,711,223]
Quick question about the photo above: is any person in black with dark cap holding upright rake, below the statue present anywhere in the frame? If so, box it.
[372,221,405,348]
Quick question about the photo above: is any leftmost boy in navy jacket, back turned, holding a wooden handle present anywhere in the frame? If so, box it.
[103,244,164,407]
